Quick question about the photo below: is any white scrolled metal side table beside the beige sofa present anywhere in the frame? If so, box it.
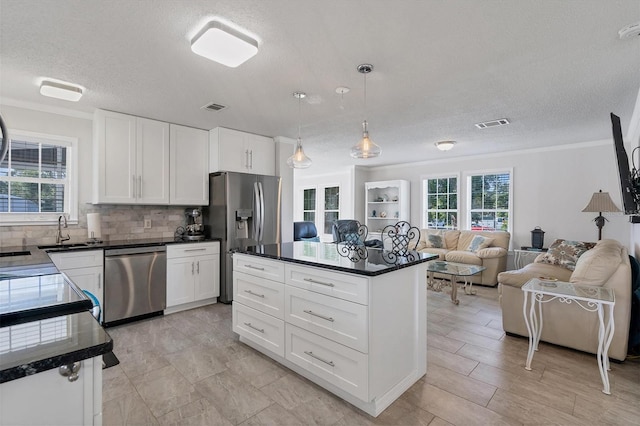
[522,278,616,395]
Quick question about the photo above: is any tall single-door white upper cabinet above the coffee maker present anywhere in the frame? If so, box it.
[169,124,209,206]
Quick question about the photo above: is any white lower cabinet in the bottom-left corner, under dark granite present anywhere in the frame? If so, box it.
[0,356,102,426]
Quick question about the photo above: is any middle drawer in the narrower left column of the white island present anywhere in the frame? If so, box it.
[233,271,284,319]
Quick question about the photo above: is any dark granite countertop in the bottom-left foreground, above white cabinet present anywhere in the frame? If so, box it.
[0,311,113,383]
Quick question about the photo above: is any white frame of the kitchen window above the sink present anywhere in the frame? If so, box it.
[0,129,79,226]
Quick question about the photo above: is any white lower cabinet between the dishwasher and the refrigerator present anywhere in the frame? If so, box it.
[167,241,220,312]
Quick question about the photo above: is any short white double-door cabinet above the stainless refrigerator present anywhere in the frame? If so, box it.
[209,127,276,175]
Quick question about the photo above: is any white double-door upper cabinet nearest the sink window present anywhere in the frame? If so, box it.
[93,110,169,204]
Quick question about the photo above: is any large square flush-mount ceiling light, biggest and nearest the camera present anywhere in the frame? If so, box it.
[191,21,258,68]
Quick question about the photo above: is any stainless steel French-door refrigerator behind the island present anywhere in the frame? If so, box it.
[203,172,281,303]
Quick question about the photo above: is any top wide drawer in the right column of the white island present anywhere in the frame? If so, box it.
[285,264,369,305]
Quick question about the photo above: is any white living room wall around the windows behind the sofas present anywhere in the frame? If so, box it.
[364,140,630,248]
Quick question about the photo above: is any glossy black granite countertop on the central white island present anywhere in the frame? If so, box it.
[238,241,438,276]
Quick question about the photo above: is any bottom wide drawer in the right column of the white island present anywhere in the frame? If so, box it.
[285,324,369,401]
